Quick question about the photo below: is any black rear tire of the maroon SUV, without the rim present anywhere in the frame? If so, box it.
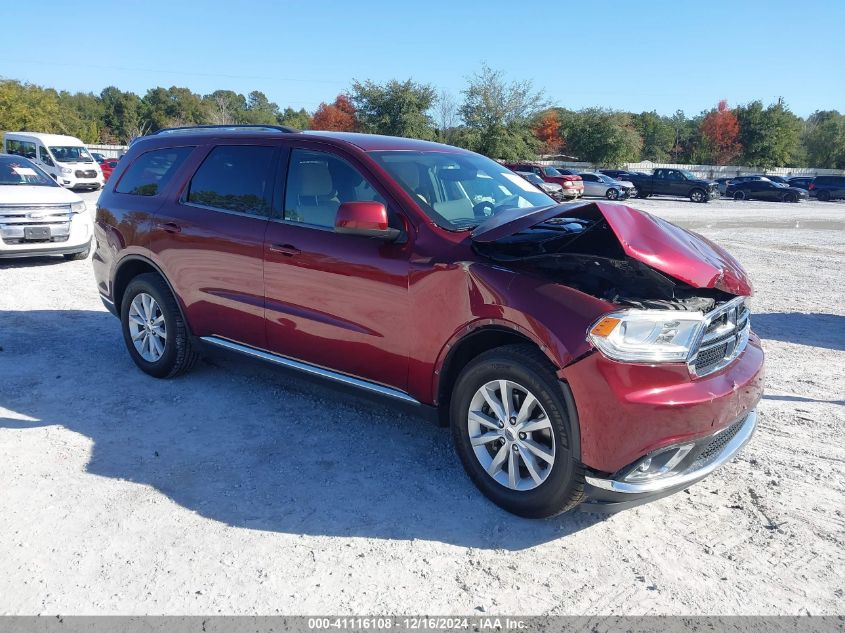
[120,273,199,378]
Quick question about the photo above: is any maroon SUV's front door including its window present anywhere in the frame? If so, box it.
[264,150,409,390]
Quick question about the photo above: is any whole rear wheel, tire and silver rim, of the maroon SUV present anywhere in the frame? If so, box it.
[120,273,198,378]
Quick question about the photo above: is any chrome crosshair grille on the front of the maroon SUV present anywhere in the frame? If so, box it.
[689,297,751,376]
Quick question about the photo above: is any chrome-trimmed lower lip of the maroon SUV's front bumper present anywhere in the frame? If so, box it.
[581,409,757,512]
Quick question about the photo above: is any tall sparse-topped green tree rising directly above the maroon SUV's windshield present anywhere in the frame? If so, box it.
[456,64,546,160]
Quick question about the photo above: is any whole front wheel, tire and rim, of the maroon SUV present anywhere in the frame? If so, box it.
[450,345,584,518]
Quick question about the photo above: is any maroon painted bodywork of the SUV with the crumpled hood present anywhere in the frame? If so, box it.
[94,130,762,471]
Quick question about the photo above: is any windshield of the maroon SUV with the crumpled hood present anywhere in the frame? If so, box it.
[371,151,555,231]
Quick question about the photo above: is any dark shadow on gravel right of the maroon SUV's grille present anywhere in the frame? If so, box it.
[751,312,845,350]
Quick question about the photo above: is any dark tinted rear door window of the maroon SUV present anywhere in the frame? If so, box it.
[187,145,276,216]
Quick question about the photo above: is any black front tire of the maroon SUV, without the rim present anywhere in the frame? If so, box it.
[450,345,584,519]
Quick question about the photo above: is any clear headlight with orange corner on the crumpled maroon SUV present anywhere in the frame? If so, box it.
[588,310,704,363]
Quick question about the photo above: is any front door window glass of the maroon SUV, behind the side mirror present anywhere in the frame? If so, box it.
[285,149,386,227]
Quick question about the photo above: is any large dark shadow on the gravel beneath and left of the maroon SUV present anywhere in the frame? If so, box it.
[0,310,605,550]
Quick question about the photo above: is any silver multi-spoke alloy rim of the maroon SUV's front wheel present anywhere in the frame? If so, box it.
[467,380,555,491]
